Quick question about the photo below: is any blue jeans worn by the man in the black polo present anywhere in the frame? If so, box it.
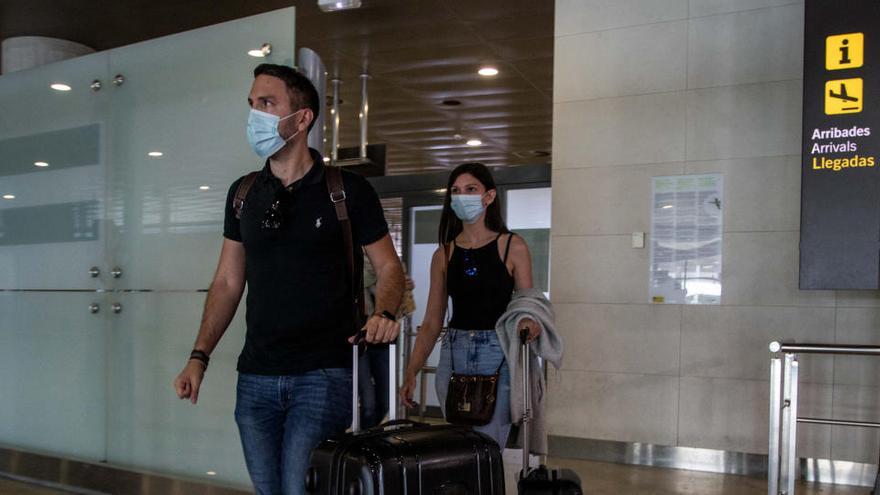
[235,368,352,495]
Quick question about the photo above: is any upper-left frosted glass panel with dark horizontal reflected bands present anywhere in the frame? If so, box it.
[0,54,108,289]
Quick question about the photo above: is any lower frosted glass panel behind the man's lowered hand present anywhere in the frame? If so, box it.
[107,293,249,485]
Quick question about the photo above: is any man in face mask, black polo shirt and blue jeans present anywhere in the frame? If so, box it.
[174,64,404,495]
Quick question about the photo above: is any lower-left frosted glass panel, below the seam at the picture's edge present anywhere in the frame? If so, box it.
[0,292,109,461]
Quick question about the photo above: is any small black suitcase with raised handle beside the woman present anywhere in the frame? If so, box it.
[517,330,584,495]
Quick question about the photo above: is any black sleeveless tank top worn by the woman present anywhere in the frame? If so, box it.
[446,234,514,330]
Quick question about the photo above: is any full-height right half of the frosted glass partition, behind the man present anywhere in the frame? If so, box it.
[107,8,294,485]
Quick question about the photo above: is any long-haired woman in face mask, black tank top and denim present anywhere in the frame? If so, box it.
[400,163,541,449]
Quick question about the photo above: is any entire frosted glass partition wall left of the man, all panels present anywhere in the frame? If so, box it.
[0,8,294,485]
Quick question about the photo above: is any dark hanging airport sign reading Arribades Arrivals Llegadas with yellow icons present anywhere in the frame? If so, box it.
[800,0,880,289]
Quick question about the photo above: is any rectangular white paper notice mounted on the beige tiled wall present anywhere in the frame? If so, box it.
[649,174,724,304]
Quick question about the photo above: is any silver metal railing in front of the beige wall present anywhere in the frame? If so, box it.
[767,342,880,495]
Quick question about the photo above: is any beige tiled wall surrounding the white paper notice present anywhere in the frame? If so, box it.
[548,0,880,463]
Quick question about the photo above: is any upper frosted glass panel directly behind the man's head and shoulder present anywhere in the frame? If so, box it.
[108,8,294,290]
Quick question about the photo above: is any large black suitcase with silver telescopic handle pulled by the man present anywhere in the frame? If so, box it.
[305,336,504,495]
